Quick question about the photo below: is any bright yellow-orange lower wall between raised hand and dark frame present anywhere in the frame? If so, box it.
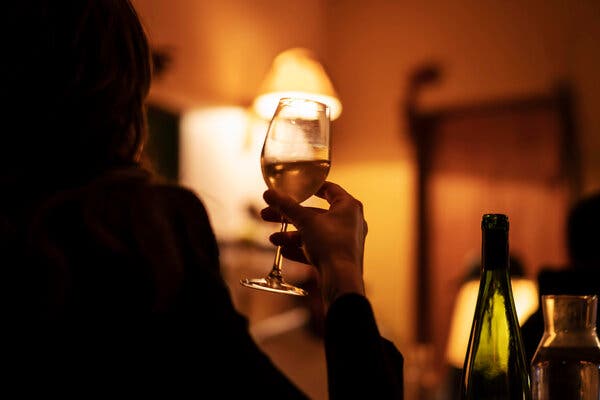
[328,158,417,346]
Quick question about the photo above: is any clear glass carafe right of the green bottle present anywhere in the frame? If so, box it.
[531,295,600,400]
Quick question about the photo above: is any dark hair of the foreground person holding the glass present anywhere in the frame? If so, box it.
[0,0,151,185]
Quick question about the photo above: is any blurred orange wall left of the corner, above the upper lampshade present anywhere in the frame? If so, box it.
[133,0,325,110]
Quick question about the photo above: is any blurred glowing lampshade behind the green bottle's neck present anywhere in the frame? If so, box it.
[446,278,539,368]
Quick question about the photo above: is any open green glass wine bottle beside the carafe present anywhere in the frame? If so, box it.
[460,214,531,400]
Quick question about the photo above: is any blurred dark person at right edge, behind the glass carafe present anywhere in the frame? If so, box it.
[521,192,600,362]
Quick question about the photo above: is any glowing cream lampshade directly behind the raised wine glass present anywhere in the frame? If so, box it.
[253,48,342,120]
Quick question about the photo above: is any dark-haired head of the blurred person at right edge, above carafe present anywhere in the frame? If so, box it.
[567,192,600,268]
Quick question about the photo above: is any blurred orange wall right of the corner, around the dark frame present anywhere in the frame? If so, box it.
[327,0,600,348]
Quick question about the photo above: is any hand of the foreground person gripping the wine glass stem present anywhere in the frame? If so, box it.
[261,181,368,306]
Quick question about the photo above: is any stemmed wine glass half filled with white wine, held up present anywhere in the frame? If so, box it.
[240,97,331,296]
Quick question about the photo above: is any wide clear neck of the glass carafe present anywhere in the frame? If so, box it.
[542,295,597,333]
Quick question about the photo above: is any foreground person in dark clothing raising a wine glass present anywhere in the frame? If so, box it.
[0,0,403,400]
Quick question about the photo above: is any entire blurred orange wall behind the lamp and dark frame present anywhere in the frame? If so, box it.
[134,0,600,349]
